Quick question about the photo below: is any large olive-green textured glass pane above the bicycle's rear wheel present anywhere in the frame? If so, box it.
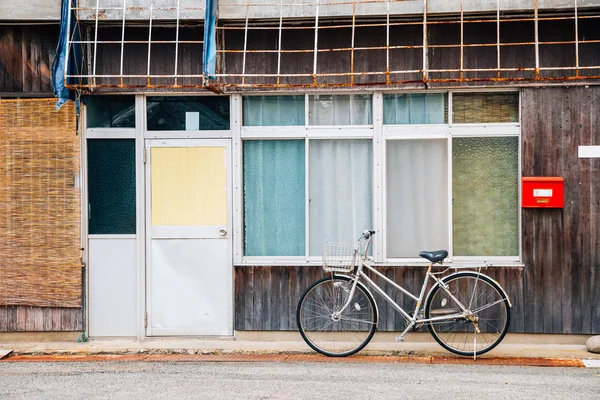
[452,137,519,256]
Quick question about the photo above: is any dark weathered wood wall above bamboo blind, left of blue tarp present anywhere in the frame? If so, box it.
[0,24,59,94]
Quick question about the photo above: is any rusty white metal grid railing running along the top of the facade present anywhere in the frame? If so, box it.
[65,0,600,92]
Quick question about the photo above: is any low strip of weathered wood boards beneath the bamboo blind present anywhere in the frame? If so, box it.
[0,306,84,332]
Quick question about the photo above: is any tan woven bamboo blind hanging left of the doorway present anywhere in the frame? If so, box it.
[0,99,82,307]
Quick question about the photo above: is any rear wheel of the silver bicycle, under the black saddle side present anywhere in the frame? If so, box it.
[425,271,511,356]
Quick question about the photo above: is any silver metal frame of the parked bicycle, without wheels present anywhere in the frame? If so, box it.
[336,236,488,341]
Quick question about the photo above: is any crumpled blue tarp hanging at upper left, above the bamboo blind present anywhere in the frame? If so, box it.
[52,0,83,114]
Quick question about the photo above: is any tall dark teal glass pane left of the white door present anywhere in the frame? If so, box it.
[87,139,136,235]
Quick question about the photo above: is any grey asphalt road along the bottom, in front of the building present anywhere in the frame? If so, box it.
[0,362,600,400]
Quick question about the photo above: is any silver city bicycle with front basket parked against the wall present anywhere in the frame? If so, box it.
[296,230,512,358]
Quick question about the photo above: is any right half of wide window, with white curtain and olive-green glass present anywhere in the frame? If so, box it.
[384,93,519,260]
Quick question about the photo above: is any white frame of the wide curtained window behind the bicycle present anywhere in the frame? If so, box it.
[231,89,522,267]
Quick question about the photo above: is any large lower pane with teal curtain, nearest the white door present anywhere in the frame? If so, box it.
[244,140,305,256]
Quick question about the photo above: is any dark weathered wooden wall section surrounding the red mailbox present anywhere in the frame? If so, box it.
[522,87,600,333]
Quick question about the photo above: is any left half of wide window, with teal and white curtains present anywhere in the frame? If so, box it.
[242,95,373,258]
